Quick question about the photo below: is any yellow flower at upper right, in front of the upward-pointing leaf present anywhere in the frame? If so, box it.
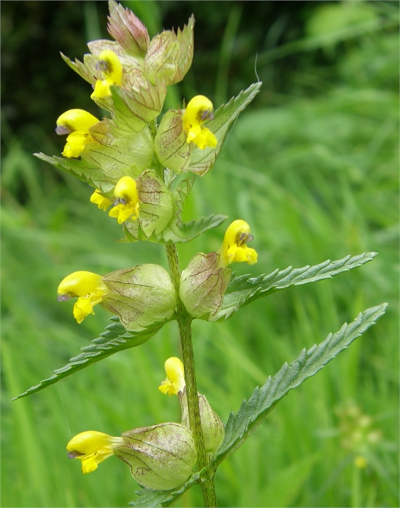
[182,95,218,150]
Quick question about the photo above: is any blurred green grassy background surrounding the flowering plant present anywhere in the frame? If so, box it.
[1,1,399,507]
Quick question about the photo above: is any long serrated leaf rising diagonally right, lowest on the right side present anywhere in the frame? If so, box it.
[214,303,387,466]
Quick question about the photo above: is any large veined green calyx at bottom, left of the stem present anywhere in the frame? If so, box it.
[114,423,197,490]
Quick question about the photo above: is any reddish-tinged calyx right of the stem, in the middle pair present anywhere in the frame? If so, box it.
[179,252,231,319]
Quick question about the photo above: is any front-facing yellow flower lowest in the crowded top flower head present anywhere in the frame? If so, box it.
[108,176,140,224]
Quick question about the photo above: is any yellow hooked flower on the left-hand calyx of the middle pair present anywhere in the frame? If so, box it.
[57,271,109,324]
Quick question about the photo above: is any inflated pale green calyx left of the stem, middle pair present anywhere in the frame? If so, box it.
[101,264,176,331]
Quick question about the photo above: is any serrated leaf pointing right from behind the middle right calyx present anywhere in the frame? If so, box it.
[212,252,377,321]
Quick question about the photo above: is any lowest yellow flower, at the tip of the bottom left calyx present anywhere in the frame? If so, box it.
[67,430,124,474]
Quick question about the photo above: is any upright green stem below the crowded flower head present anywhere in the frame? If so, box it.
[166,245,217,507]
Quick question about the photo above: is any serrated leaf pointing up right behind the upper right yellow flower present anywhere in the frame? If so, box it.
[187,82,262,176]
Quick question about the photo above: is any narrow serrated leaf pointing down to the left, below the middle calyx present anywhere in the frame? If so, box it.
[12,317,165,400]
